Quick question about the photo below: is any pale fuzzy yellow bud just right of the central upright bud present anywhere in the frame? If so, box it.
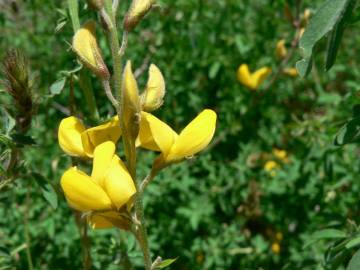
[141,64,165,112]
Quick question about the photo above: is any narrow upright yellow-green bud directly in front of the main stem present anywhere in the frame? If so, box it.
[122,61,141,140]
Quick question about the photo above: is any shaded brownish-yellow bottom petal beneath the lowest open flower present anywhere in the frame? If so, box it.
[88,211,130,230]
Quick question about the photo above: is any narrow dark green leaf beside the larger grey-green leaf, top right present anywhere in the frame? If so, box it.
[325,1,355,71]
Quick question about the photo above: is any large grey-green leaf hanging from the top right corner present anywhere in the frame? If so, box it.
[296,0,352,77]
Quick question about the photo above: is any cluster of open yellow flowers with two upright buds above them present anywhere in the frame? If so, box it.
[58,50,217,229]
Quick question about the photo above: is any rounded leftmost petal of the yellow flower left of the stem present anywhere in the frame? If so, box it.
[58,116,86,157]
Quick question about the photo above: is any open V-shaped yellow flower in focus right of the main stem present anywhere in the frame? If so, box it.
[136,109,217,167]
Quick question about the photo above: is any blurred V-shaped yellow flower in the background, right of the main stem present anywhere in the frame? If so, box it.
[237,64,271,90]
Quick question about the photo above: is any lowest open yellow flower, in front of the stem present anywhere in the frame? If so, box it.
[60,141,136,228]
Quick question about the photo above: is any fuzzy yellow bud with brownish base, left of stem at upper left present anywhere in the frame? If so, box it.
[72,21,110,79]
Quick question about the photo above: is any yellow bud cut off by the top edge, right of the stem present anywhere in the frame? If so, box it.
[124,0,155,32]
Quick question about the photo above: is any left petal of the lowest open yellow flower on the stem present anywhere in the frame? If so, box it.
[60,167,111,212]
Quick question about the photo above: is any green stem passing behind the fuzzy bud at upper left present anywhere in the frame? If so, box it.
[68,0,99,120]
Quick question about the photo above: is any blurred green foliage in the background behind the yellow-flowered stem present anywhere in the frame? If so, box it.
[0,0,360,270]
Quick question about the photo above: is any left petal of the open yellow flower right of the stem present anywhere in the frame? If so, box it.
[136,112,178,154]
